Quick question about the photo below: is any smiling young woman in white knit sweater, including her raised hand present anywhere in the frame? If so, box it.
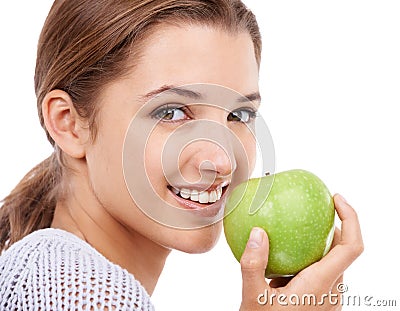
[0,0,363,310]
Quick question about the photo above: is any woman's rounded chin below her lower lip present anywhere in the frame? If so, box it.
[171,221,222,254]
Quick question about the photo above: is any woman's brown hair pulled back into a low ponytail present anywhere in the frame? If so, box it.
[0,0,261,252]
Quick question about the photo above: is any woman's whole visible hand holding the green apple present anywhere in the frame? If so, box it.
[240,195,364,311]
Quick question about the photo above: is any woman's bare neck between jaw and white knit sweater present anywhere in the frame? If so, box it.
[51,173,170,295]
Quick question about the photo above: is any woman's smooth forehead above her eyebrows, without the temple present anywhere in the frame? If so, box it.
[134,25,258,94]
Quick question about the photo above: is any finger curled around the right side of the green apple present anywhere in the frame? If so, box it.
[303,195,363,284]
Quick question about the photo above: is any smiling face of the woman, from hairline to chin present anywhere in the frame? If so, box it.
[86,26,258,253]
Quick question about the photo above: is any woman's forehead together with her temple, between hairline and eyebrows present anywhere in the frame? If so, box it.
[95,25,258,115]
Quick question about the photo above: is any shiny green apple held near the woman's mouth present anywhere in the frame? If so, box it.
[224,169,335,278]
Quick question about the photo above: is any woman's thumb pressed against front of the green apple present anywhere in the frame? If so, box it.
[240,227,269,301]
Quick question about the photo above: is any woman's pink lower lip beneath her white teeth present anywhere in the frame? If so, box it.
[168,186,228,217]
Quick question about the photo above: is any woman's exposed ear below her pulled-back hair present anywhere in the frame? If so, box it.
[42,90,89,158]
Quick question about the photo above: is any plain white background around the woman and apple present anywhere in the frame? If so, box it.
[0,0,400,311]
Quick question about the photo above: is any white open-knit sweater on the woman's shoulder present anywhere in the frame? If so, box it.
[0,228,154,311]
